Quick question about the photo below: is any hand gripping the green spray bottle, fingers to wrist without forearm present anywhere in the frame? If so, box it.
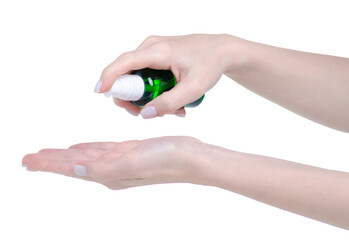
[95,34,243,118]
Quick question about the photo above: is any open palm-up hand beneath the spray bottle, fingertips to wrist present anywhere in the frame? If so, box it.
[23,137,199,189]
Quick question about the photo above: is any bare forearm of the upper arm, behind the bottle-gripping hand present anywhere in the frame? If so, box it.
[225,38,349,132]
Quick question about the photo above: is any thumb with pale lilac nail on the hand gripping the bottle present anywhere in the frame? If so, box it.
[141,79,204,118]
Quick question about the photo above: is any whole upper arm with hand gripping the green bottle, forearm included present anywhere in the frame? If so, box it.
[95,34,349,132]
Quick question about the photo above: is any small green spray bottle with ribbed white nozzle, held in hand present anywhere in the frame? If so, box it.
[105,68,205,107]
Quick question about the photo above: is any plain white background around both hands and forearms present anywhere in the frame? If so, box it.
[0,0,349,240]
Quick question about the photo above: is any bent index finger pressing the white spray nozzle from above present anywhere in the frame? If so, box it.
[99,47,169,93]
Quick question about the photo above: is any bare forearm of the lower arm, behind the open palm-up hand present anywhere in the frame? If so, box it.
[191,145,349,229]
